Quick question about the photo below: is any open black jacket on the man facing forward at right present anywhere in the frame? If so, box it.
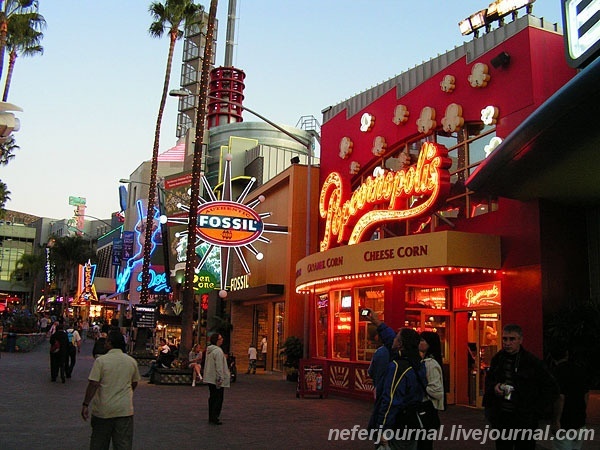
[483,347,558,424]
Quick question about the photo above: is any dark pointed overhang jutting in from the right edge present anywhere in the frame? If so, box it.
[467,58,600,204]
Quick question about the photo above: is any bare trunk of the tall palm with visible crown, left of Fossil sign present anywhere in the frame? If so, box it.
[140,29,177,303]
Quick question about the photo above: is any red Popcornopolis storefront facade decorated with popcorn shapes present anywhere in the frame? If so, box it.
[296,15,576,406]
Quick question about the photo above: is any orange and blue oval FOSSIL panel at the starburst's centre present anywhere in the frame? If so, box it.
[196,201,263,247]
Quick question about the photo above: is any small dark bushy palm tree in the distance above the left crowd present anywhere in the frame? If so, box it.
[50,236,96,312]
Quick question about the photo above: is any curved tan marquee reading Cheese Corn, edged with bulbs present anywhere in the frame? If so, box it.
[296,231,501,291]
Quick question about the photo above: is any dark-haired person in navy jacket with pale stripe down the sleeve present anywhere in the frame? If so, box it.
[376,328,426,450]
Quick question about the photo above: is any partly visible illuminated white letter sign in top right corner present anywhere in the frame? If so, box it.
[562,0,600,68]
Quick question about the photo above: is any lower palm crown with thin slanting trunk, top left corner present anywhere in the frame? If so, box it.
[2,8,46,102]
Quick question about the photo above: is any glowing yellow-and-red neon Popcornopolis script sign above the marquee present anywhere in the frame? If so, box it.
[319,142,452,251]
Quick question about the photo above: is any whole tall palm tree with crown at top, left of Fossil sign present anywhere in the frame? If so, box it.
[140,0,202,303]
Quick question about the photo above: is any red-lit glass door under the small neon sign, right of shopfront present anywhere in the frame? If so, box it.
[459,309,502,408]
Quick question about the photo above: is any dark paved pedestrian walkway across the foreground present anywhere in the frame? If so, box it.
[0,340,600,450]
